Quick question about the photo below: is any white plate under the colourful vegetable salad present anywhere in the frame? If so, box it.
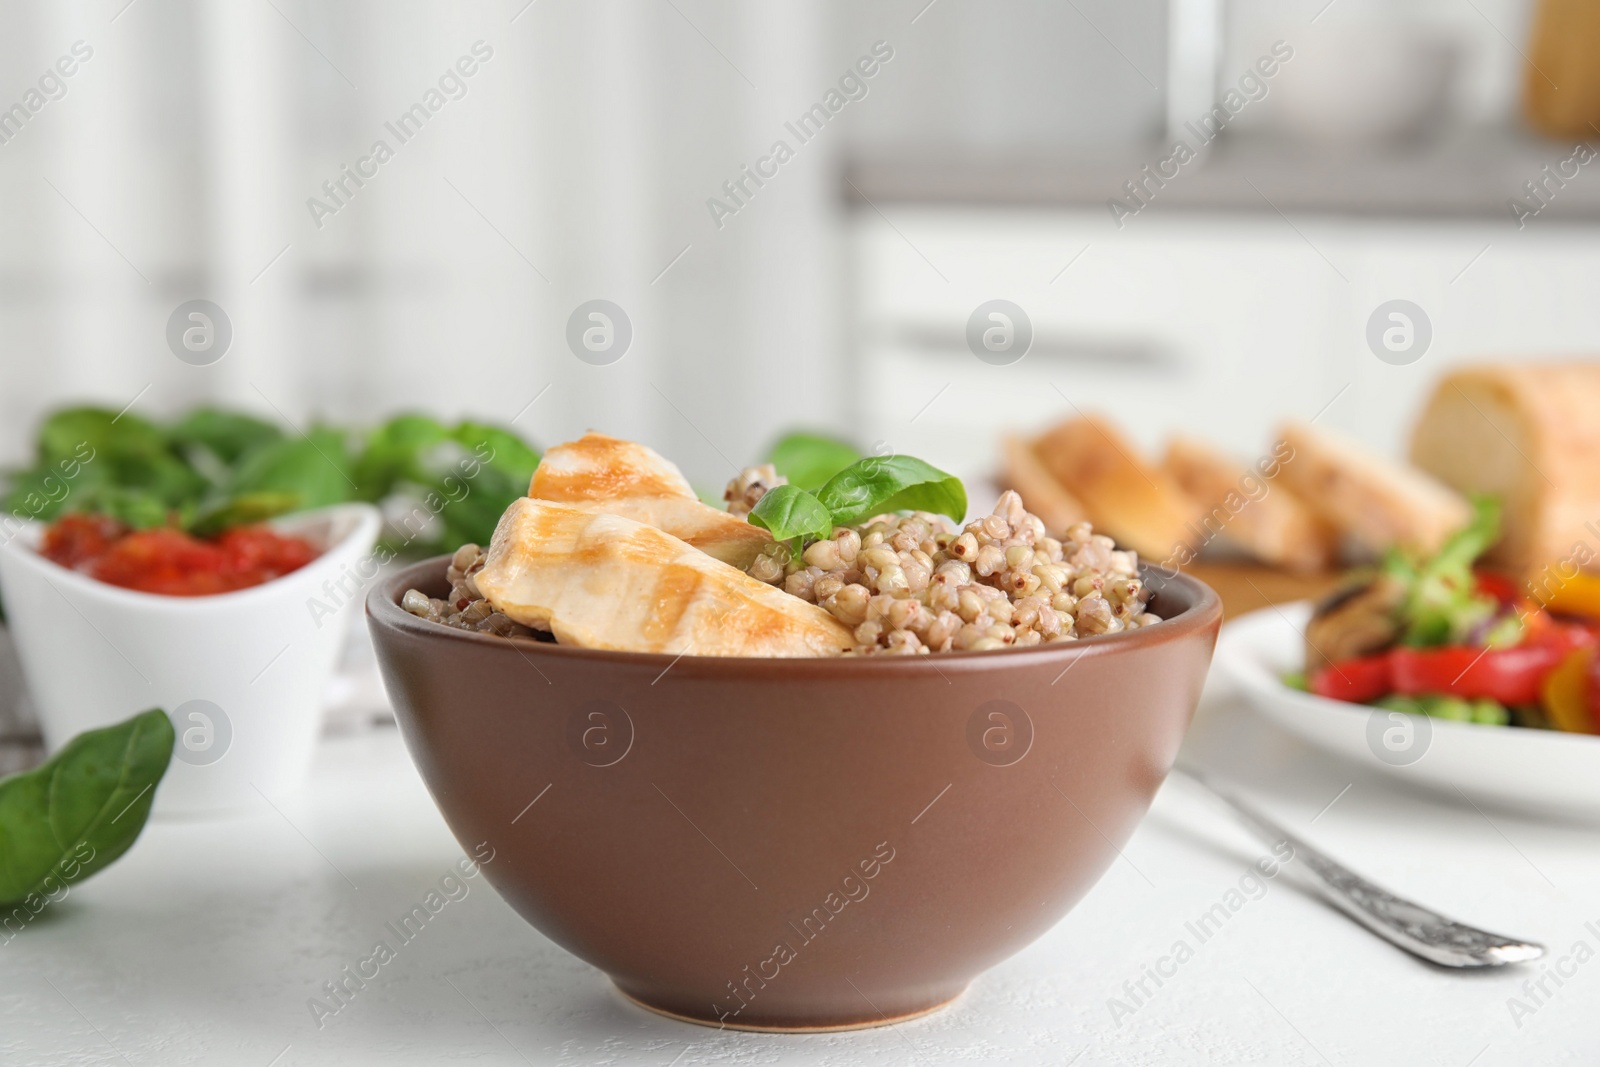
[1213,603,1600,821]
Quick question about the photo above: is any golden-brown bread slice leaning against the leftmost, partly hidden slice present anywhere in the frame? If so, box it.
[1034,416,1200,561]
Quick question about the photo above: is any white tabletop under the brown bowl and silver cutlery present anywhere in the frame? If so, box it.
[0,691,1600,1067]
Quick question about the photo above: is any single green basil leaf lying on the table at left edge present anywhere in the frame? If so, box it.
[0,709,173,905]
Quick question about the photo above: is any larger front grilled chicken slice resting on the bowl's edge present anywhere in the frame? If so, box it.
[475,498,853,657]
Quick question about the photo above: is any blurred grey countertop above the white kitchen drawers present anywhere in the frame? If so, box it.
[842,128,1600,226]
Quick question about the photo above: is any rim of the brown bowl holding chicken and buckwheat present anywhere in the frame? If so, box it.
[366,553,1222,677]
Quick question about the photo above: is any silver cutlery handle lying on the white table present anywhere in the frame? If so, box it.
[1173,766,1544,968]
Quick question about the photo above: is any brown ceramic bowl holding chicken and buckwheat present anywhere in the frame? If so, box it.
[366,557,1221,1030]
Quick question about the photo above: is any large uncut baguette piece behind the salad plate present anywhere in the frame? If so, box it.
[1411,363,1600,574]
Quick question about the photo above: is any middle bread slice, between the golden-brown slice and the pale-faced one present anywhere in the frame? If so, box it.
[1162,437,1339,573]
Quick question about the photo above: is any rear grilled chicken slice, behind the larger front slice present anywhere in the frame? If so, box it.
[528,434,771,569]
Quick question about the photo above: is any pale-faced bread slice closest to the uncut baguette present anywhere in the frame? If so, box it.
[1278,422,1472,552]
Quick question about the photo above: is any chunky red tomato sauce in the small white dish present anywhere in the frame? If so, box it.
[40,515,322,597]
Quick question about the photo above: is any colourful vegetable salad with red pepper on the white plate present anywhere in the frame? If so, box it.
[1286,498,1600,734]
